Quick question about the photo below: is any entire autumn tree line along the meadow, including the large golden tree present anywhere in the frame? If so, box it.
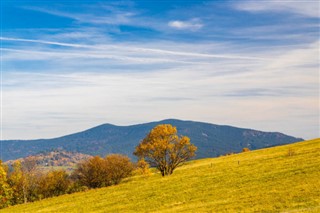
[0,124,197,209]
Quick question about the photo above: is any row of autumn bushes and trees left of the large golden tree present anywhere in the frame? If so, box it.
[0,154,134,209]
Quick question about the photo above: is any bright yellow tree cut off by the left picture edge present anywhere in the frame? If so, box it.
[0,160,12,209]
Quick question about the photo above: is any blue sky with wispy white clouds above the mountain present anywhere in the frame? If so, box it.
[0,0,320,140]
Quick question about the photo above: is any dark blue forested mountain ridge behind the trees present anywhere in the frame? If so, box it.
[1,119,303,161]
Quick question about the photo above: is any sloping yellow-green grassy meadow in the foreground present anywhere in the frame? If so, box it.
[1,139,320,213]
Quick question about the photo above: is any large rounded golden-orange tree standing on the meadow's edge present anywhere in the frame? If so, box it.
[134,124,197,176]
